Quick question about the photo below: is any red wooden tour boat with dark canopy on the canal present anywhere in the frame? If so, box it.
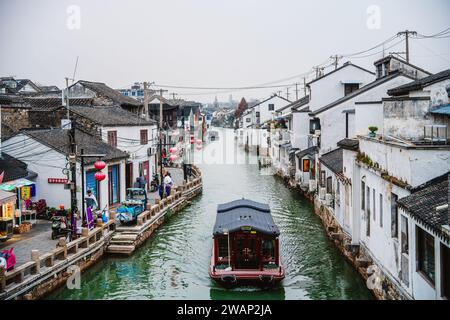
[209,199,284,286]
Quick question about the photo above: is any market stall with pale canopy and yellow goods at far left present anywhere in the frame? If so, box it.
[0,178,36,226]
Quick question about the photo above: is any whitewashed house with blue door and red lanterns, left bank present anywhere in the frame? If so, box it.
[3,128,129,209]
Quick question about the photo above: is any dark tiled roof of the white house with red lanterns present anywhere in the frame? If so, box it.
[22,128,128,163]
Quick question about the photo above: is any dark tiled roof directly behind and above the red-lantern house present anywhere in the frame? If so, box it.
[70,105,156,126]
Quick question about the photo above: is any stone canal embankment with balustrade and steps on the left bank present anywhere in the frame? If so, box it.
[0,166,203,300]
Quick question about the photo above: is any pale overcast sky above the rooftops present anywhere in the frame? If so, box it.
[0,0,450,102]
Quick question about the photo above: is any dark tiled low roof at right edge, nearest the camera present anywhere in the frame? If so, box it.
[397,172,450,240]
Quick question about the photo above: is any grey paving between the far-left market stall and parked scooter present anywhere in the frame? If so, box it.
[0,220,58,267]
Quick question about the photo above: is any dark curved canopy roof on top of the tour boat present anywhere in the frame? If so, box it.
[213,199,280,236]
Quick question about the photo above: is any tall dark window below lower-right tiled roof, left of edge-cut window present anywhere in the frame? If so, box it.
[416,227,435,286]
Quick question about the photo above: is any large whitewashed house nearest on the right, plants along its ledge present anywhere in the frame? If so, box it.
[344,71,450,299]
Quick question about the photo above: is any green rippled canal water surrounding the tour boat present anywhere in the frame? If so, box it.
[48,129,372,300]
